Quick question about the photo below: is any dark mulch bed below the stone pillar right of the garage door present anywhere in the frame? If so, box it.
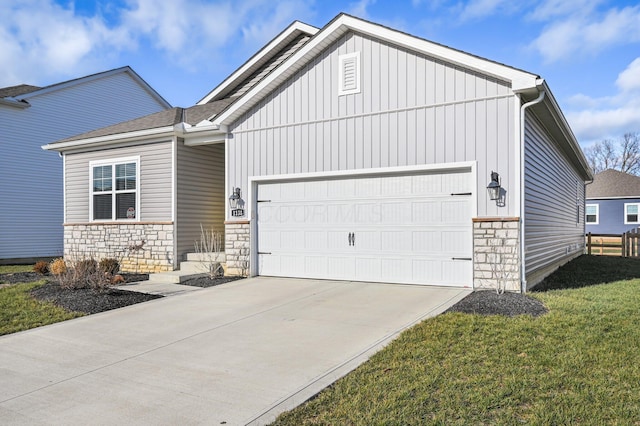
[445,290,548,317]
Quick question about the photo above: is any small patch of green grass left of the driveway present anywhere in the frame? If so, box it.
[0,282,83,335]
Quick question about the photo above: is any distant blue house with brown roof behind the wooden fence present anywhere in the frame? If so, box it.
[585,170,640,234]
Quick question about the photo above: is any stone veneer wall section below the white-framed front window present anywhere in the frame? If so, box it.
[64,222,174,273]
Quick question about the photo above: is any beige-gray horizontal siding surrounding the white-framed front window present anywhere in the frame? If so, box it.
[65,140,173,224]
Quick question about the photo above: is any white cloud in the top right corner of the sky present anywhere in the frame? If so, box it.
[532,4,640,62]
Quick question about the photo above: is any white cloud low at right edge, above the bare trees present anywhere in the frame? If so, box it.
[567,58,640,144]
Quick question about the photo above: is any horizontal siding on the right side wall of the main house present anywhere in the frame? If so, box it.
[524,111,585,287]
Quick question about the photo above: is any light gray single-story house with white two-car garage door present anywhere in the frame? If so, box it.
[44,14,592,291]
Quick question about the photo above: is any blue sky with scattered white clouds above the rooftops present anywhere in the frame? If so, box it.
[0,0,640,147]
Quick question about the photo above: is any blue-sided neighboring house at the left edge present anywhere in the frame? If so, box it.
[0,67,171,263]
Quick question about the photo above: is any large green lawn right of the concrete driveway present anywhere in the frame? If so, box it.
[276,256,640,425]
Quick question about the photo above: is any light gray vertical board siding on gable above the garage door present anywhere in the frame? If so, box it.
[227,32,518,216]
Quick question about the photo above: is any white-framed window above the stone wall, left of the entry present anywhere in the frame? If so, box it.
[89,157,140,221]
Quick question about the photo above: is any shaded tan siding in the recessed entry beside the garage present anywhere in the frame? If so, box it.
[176,141,227,261]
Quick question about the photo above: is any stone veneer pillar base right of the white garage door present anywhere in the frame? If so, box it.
[473,218,521,292]
